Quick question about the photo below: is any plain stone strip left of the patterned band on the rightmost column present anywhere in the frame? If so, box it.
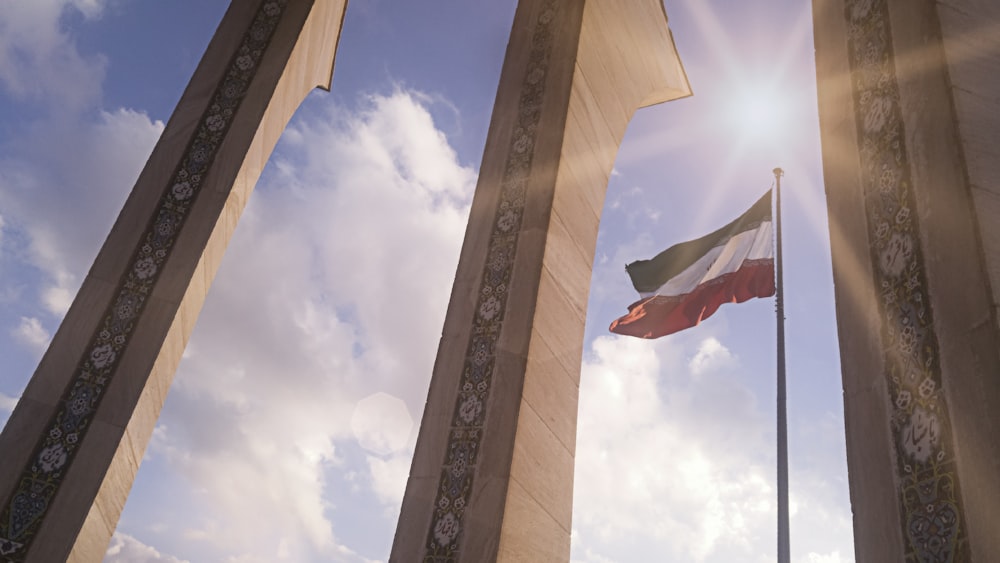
[813,0,903,563]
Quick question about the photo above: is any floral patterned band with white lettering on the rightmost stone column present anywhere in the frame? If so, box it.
[845,0,970,563]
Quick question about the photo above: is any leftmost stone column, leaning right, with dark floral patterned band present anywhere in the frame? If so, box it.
[0,0,346,562]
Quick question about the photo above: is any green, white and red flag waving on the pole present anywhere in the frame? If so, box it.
[610,190,774,338]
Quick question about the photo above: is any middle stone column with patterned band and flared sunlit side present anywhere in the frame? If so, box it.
[390,0,691,563]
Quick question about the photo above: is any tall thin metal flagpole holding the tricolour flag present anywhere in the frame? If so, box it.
[774,168,791,563]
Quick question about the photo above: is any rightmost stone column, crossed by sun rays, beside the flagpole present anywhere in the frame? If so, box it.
[813,0,1000,563]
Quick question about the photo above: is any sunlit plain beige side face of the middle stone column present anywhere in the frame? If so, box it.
[498,0,689,561]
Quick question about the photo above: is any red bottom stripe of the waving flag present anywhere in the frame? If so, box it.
[610,259,774,338]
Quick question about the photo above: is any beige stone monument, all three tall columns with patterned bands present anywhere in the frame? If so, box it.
[0,0,1000,563]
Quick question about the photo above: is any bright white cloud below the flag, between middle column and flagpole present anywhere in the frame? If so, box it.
[575,337,774,561]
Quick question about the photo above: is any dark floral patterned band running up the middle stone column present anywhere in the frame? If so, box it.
[423,0,559,563]
